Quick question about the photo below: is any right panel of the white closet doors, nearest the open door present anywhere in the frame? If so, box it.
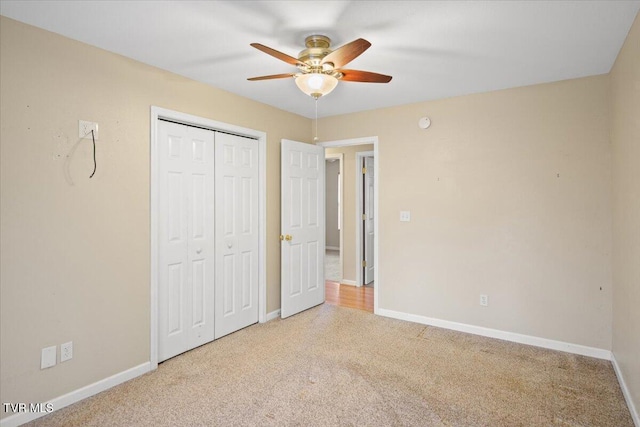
[215,132,259,338]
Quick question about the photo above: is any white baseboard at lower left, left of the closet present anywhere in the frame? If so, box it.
[0,362,151,427]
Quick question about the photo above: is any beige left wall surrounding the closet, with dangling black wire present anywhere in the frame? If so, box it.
[0,17,311,416]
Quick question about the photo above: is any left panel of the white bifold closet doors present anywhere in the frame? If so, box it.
[158,121,214,361]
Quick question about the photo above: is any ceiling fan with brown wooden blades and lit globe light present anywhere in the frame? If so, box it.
[247,35,391,100]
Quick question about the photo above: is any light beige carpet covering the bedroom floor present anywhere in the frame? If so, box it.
[31,305,633,427]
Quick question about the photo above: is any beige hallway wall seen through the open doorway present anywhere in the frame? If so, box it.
[325,145,373,282]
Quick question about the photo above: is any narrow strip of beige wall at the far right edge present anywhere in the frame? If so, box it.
[611,15,640,411]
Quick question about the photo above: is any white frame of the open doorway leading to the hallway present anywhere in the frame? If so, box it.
[316,136,383,314]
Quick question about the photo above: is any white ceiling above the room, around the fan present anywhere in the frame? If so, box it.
[0,0,640,117]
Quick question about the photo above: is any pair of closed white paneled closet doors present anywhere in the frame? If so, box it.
[158,121,259,361]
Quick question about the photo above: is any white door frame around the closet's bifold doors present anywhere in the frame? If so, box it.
[149,106,267,370]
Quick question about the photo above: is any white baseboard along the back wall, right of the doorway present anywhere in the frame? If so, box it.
[376,308,611,360]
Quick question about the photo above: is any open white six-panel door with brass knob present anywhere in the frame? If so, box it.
[280,140,325,318]
